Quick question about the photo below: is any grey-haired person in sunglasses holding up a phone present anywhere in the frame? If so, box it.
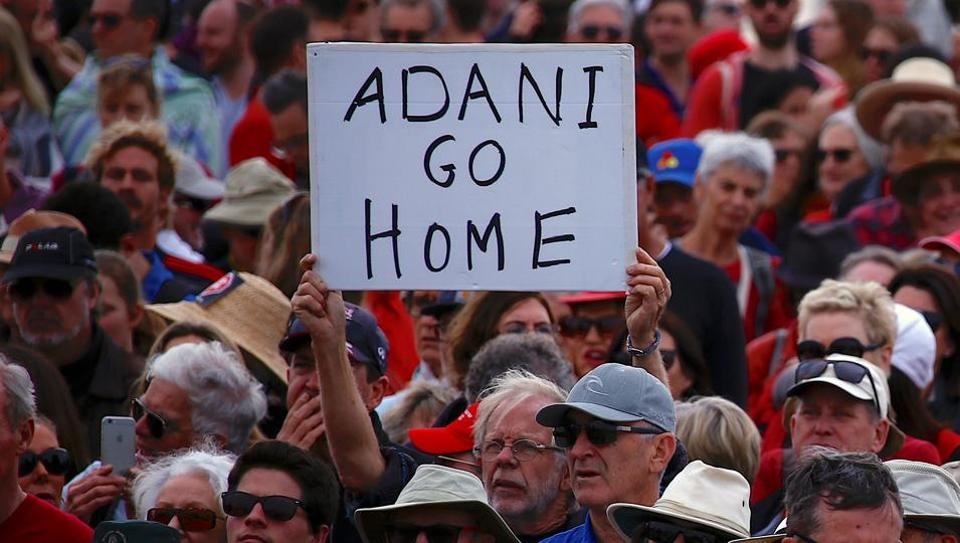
[64,343,267,523]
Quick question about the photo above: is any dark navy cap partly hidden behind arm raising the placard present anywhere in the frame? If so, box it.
[280,302,390,375]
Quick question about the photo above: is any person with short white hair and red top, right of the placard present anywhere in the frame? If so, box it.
[677,133,790,341]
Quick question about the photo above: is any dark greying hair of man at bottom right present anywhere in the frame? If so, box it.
[784,447,903,535]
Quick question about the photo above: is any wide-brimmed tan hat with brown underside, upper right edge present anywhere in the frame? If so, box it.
[856,58,960,140]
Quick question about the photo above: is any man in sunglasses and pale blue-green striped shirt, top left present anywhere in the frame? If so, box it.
[53,0,226,175]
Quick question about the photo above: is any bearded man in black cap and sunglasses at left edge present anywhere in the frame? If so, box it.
[3,226,143,451]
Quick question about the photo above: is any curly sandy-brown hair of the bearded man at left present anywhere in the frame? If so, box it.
[86,120,177,191]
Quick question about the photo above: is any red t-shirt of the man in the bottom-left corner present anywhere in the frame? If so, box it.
[0,495,93,543]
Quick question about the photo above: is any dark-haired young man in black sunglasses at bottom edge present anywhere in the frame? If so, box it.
[220,441,340,543]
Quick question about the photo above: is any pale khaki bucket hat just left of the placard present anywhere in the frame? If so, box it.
[203,158,296,226]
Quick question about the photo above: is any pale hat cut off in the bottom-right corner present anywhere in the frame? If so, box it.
[884,460,960,535]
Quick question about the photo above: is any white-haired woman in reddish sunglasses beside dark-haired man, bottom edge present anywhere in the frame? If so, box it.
[133,449,236,543]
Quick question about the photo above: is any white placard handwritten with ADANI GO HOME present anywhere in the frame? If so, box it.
[307,43,637,291]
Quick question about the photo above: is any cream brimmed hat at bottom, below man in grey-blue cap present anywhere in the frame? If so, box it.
[607,460,750,541]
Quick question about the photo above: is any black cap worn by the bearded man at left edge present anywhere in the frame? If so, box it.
[3,226,97,282]
